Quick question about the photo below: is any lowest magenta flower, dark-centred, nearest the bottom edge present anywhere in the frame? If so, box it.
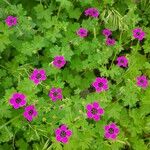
[55,125,72,143]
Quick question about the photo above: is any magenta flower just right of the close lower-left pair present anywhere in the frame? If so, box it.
[49,88,63,101]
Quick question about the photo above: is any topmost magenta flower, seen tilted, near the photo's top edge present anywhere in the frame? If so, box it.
[84,8,99,18]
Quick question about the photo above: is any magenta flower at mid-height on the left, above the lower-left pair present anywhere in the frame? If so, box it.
[30,69,46,85]
